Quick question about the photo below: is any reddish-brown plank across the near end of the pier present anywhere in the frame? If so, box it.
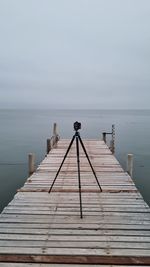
[0,251,150,265]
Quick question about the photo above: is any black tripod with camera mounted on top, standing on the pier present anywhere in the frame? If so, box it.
[48,122,102,218]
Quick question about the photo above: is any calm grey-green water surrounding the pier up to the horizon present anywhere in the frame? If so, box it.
[0,110,150,214]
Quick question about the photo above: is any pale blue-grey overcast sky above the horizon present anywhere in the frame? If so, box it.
[0,0,150,109]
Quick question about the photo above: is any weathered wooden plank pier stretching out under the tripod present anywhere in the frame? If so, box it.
[0,129,150,267]
